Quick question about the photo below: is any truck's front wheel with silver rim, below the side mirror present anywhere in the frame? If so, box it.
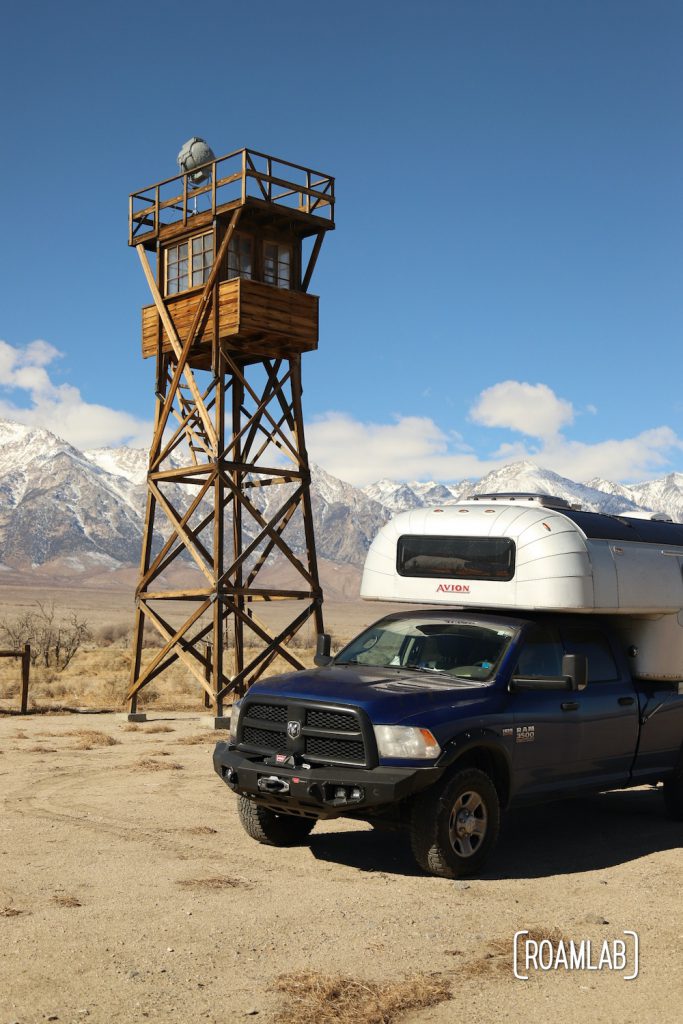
[410,768,501,879]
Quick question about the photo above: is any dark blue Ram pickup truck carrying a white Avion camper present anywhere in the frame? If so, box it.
[214,495,683,878]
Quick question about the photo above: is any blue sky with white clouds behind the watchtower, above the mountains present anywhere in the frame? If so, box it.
[0,0,683,483]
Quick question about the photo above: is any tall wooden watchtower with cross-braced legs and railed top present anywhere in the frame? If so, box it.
[128,147,335,717]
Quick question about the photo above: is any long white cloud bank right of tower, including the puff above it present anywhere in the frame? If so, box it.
[306,389,683,485]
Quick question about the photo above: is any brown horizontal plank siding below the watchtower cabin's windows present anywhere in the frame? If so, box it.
[142,278,317,362]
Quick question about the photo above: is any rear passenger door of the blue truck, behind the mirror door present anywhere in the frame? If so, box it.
[561,623,639,787]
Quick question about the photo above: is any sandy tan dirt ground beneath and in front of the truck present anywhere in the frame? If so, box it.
[0,713,683,1024]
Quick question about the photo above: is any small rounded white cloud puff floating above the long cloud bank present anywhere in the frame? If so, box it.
[470,381,573,437]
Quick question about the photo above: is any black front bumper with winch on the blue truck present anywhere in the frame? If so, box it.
[213,742,444,818]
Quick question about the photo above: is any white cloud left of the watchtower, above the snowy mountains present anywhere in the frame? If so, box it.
[0,340,152,449]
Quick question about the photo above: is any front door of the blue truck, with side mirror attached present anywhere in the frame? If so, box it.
[510,625,580,797]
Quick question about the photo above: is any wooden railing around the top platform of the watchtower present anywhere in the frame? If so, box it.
[128,150,335,246]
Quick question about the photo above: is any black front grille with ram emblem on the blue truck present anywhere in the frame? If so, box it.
[238,697,373,767]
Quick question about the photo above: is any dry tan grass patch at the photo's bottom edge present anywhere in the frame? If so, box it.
[275,971,451,1024]
